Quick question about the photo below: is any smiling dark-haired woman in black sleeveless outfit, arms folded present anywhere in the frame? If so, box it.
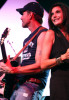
[41,3,69,100]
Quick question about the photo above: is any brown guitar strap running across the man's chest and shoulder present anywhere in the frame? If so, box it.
[12,27,45,61]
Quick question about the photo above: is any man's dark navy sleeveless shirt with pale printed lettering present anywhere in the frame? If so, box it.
[18,26,49,87]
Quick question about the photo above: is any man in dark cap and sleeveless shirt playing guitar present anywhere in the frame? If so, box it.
[0,2,49,100]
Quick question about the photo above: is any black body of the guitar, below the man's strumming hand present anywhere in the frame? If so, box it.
[2,74,16,99]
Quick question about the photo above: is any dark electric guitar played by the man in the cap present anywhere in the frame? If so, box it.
[0,28,18,99]
